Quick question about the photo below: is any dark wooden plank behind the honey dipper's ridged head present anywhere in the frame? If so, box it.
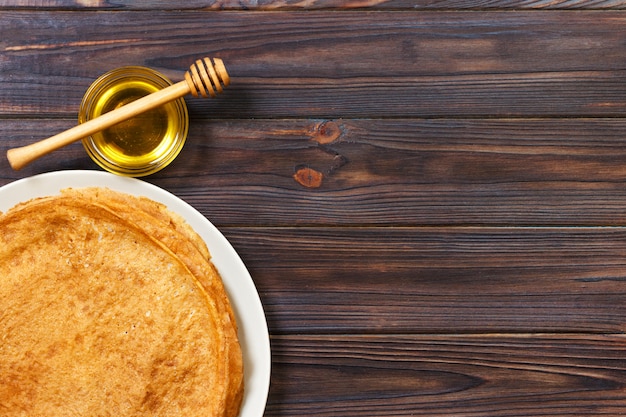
[0,11,626,118]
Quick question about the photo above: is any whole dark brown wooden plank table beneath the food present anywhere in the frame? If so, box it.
[0,0,626,417]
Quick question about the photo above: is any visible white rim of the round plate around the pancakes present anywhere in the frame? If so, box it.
[0,170,271,417]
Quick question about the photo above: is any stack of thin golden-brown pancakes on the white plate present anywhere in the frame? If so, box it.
[0,188,243,417]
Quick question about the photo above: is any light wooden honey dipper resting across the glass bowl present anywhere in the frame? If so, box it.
[7,58,230,170]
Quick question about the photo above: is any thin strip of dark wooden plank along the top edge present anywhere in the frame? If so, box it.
[0,0,626,10]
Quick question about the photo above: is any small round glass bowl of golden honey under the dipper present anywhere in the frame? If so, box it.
[79,67,189,177]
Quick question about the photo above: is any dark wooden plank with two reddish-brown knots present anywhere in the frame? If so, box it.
[0,118,626,226]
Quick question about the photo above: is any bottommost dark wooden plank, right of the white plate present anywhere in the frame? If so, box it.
[266,334,626,417]
